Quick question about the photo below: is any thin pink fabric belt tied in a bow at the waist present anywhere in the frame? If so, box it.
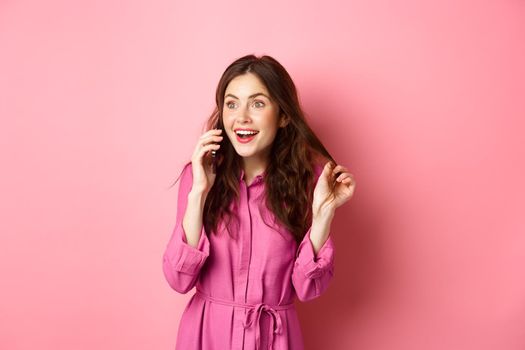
[195,289,294,350]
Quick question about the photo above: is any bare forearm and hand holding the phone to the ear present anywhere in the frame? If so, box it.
[182,129,223,248]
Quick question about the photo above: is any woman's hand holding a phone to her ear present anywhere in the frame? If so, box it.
[191,129,223,194]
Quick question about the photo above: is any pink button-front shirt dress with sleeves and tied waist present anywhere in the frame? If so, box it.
[162,163,335,350]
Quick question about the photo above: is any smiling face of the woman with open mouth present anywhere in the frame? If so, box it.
[222,73,279,165]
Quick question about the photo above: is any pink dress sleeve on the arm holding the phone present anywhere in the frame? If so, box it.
[162,163,210,294]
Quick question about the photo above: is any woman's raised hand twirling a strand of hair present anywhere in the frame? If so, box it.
[312,162,356,216]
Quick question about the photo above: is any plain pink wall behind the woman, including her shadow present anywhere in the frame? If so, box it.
[0,0,525,350]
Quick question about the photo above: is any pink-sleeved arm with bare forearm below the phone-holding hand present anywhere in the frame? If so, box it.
[162,163,210,294]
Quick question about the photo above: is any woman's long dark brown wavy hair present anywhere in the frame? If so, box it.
[170,54,337,242]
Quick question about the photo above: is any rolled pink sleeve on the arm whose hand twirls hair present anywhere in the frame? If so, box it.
[292,228,335,301]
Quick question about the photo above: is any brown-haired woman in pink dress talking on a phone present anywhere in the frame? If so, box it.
[163,55,355,350]
